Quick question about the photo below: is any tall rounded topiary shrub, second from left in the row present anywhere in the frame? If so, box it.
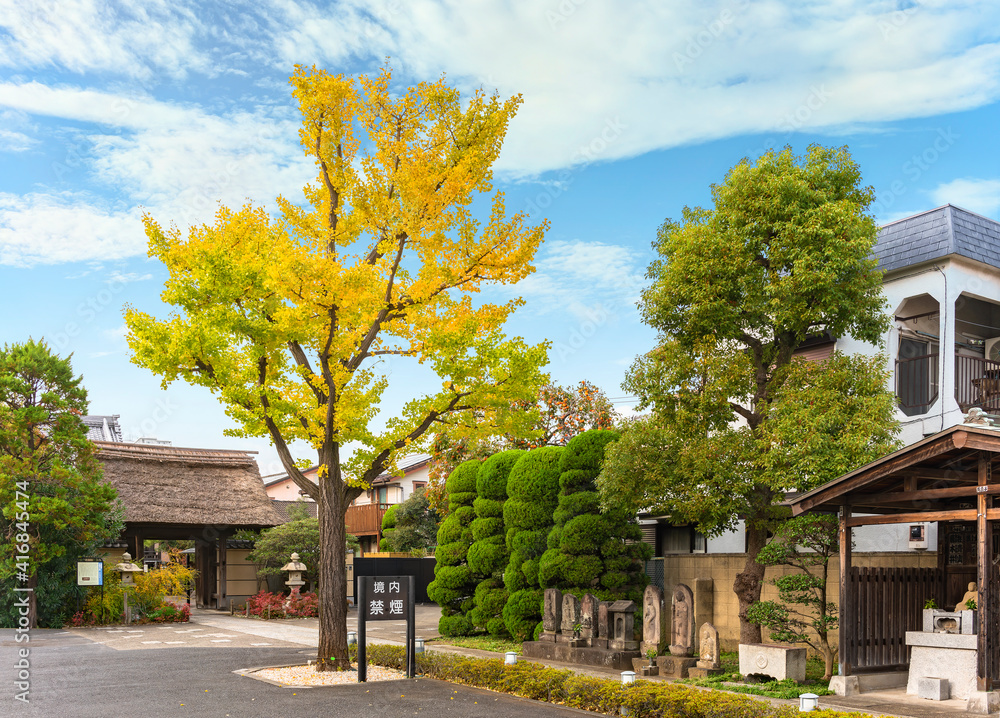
[468,449,525,636]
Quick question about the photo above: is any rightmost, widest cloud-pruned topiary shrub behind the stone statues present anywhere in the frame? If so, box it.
[538,429,650,602]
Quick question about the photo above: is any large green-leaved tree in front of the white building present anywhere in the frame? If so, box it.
[599,146,898,643]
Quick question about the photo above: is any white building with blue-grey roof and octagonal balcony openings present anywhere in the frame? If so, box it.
[643,204,1000,556]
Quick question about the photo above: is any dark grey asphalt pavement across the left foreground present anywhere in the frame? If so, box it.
[0,629,592,718]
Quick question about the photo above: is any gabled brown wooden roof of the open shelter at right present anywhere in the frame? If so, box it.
[787,424,1000,525]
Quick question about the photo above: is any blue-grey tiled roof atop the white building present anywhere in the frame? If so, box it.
[874,210,1000,272]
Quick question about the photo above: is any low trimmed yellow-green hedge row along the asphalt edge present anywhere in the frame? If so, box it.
[368,645,867,718]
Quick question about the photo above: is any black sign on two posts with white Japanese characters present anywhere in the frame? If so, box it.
[358,576,417,683]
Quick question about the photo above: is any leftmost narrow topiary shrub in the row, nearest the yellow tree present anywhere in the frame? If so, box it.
[427,460,480,636]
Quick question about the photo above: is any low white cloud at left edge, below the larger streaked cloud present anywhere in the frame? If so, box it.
[0,193,146,267]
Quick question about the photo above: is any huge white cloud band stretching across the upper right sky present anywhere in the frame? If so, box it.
[262,0,1000,174]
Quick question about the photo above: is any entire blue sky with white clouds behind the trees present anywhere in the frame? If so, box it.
[0,0,1000,473]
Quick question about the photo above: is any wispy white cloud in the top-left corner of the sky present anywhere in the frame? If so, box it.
[0,0,211,78]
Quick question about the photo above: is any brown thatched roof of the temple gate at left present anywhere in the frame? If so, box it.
[94,441,282,529]
